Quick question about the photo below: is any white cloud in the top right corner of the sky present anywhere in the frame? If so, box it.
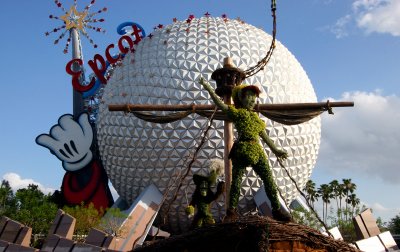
[329,0,400,38]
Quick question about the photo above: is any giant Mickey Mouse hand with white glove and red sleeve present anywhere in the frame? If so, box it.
[36,113,113,211]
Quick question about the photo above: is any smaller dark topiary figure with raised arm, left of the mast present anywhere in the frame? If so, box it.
[186,159,225,229]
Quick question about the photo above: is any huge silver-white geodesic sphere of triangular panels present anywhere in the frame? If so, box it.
[97,17,320,232]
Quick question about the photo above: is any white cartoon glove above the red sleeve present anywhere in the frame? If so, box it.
[36,113,93,171]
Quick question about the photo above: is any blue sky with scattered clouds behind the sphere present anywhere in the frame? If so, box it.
[0,0,400,221]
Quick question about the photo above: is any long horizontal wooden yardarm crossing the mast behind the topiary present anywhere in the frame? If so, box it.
[108,99,354,112]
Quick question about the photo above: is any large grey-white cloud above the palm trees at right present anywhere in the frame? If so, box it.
[317,91,400,184]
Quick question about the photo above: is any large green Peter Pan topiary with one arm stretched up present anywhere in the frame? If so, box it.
[200,78,291,221]
